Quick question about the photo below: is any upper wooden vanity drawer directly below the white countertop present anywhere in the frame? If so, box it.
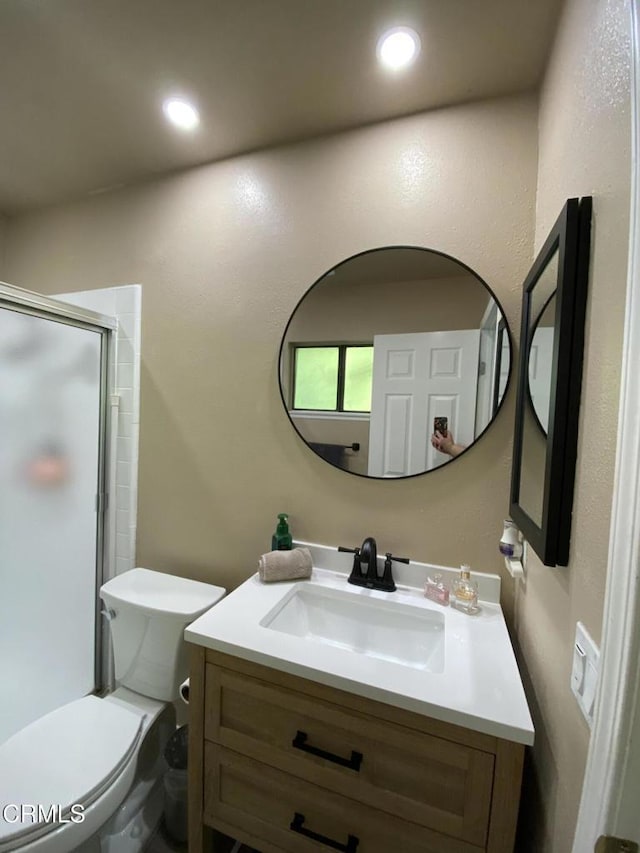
[204,664,494,850]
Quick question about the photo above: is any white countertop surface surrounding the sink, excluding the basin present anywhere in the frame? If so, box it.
[185,543,534,744]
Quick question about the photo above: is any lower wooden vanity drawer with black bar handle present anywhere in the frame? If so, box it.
[204,743,484,853]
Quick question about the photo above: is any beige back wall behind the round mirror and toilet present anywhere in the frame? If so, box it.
[0,97,537,610]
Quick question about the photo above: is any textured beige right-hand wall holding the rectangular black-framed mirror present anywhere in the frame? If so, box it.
[516,0,631,853]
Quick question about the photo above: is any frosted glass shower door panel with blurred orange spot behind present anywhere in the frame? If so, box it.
[0,308,103,743]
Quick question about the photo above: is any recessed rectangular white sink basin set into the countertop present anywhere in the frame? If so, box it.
[260,582,444,672]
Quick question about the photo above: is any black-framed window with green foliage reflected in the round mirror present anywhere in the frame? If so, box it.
[293,344,373,412]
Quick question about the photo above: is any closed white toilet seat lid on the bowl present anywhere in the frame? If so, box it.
[0,696,144,848]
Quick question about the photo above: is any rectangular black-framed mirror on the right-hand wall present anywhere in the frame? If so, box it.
[510,197,592,566]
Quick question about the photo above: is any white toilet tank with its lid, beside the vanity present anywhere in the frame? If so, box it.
[100,568,225,701]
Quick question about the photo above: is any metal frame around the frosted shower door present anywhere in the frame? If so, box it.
[0,282,118,692]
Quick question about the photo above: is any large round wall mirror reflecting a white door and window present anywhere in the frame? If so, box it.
[279,246,511,478]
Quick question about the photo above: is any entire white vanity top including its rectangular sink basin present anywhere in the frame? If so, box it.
[185,543,533,744]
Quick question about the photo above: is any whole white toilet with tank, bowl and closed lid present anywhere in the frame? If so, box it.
[0,569,225,853]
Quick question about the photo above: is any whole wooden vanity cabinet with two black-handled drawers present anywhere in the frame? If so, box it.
[189,646,524,853]
